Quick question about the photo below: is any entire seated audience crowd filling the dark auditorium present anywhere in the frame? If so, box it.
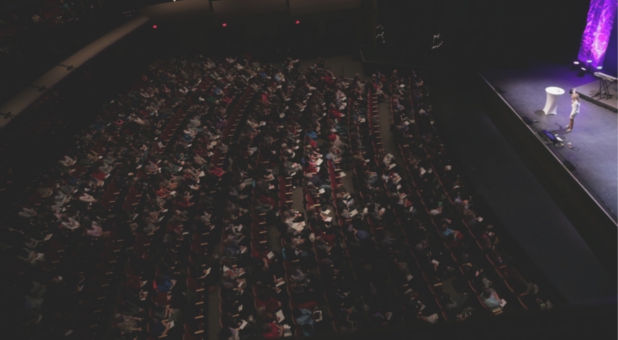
[2,51,542,339]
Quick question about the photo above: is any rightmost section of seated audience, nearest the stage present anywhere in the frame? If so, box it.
[384,67,551,320]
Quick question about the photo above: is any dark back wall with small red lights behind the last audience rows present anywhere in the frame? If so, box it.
[162,10,362,61]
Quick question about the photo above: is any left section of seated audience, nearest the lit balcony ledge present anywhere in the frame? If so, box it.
[2,57,262,338]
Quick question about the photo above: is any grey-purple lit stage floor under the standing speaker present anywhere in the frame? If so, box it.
[482,64,618,219]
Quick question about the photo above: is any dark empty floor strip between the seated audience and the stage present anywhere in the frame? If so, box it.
[433,75,616,304]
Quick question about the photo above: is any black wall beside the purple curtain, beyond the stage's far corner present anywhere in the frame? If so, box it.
[372,0,589,67]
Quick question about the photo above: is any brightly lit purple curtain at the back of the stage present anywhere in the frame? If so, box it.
[577,0,616,68]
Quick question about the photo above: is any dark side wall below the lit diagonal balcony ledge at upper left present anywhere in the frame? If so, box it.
[0,26,179,210]
